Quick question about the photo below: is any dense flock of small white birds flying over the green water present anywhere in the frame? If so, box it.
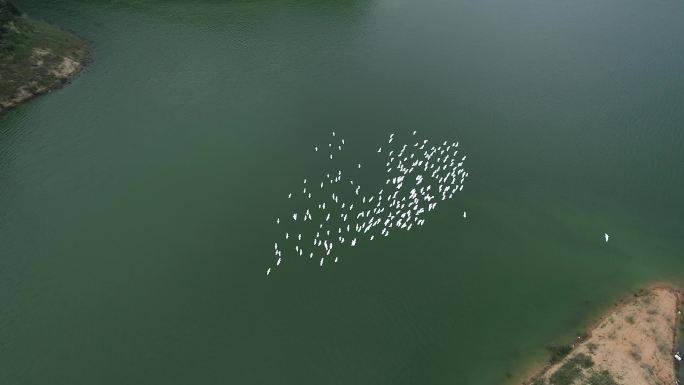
[266,131,468,275]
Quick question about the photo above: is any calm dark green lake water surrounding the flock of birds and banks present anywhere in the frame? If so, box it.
[0,0,684,385]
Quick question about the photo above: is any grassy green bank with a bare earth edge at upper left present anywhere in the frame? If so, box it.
[0,0,86,111]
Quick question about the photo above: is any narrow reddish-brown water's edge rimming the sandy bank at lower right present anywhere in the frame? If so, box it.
[510,282,684,385]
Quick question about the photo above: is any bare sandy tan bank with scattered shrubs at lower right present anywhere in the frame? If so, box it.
[524,284,682,385]
